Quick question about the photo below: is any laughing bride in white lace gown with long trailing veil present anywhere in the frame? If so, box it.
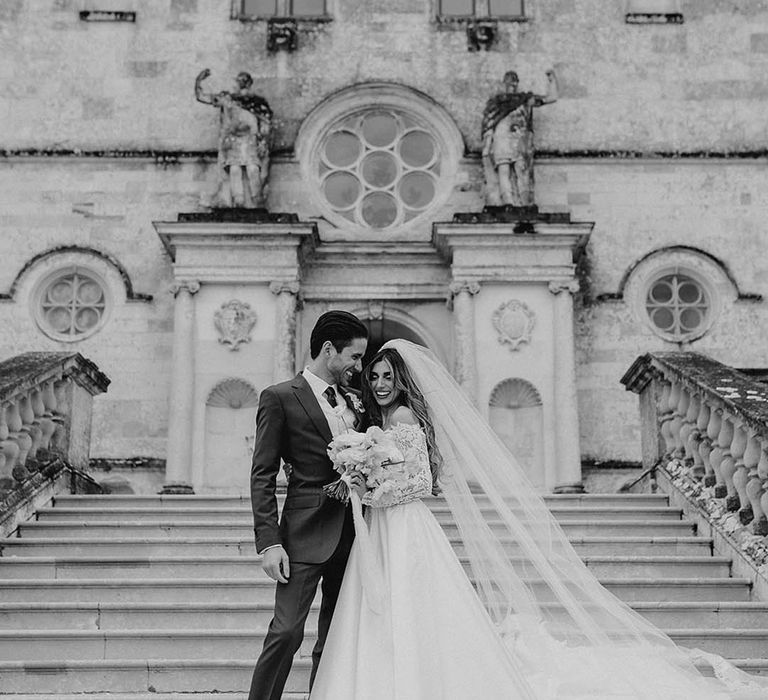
[310,340,768,700]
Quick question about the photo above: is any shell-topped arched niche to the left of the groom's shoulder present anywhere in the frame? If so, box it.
[202,378,259,494]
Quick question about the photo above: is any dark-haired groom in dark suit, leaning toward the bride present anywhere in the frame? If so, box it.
[248,311,368,700]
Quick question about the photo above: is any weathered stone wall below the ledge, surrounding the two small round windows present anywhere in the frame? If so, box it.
[0,158,768,460]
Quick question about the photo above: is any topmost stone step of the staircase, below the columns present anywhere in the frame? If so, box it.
[53,492,669,512]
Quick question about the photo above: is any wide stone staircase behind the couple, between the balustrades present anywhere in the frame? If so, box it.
[0,494,768,700]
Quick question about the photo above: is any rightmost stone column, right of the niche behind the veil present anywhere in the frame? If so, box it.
[549,280,584,493]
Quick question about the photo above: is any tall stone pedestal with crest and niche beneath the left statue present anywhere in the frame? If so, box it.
[154,209,317,493]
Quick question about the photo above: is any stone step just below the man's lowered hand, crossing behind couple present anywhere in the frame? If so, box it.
[0,577,750,603]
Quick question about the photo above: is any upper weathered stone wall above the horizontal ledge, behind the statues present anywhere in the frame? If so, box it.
[0,0,768,152]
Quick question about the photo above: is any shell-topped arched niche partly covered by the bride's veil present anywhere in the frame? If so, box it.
[488,377,545,489]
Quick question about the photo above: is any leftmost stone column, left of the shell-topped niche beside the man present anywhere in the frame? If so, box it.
[161,280,200,494]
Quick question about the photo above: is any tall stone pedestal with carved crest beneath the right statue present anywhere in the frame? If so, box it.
[433,213,594,491]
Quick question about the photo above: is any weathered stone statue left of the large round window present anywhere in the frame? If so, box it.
[195,68,272,208]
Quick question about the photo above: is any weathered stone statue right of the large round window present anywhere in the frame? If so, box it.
[482,70,557,207]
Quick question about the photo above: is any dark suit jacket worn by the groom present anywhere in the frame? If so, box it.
[251,374,364,564]
